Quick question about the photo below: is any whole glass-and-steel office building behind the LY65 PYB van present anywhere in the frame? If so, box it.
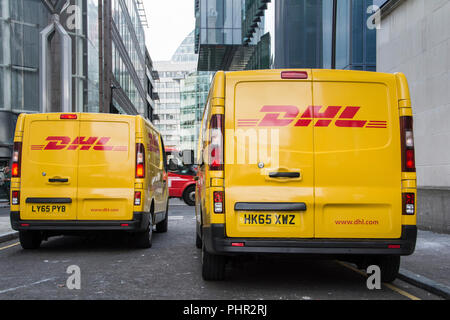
[0,0,157,200]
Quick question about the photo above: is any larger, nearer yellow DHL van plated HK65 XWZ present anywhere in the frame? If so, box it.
[196,70,417,282]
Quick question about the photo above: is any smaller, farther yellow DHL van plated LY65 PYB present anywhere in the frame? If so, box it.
[11,113,168,249]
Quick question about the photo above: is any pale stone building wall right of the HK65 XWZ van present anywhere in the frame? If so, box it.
[377,0,450,233]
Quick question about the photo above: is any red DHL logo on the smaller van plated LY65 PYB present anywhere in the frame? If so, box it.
[31,137,128,151]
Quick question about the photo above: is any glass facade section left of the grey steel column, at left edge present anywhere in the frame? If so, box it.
[0,0,49,113]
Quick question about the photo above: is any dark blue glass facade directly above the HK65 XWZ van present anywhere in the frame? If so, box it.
[273,0,376,71]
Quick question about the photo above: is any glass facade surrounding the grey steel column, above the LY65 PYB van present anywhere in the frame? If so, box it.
[0,0,152,116]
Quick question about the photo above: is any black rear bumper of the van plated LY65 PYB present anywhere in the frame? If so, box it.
[10,211,150,232]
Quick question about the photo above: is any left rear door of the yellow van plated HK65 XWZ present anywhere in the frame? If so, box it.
[225,70,314,238]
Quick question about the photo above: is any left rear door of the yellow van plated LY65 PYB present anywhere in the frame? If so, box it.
[21,114,79,220]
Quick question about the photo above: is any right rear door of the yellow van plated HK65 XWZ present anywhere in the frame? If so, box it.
[313,70,402,239]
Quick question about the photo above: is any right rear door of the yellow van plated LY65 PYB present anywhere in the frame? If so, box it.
[78,114,135,221]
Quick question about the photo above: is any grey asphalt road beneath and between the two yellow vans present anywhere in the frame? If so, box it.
[0,200,438,300]
